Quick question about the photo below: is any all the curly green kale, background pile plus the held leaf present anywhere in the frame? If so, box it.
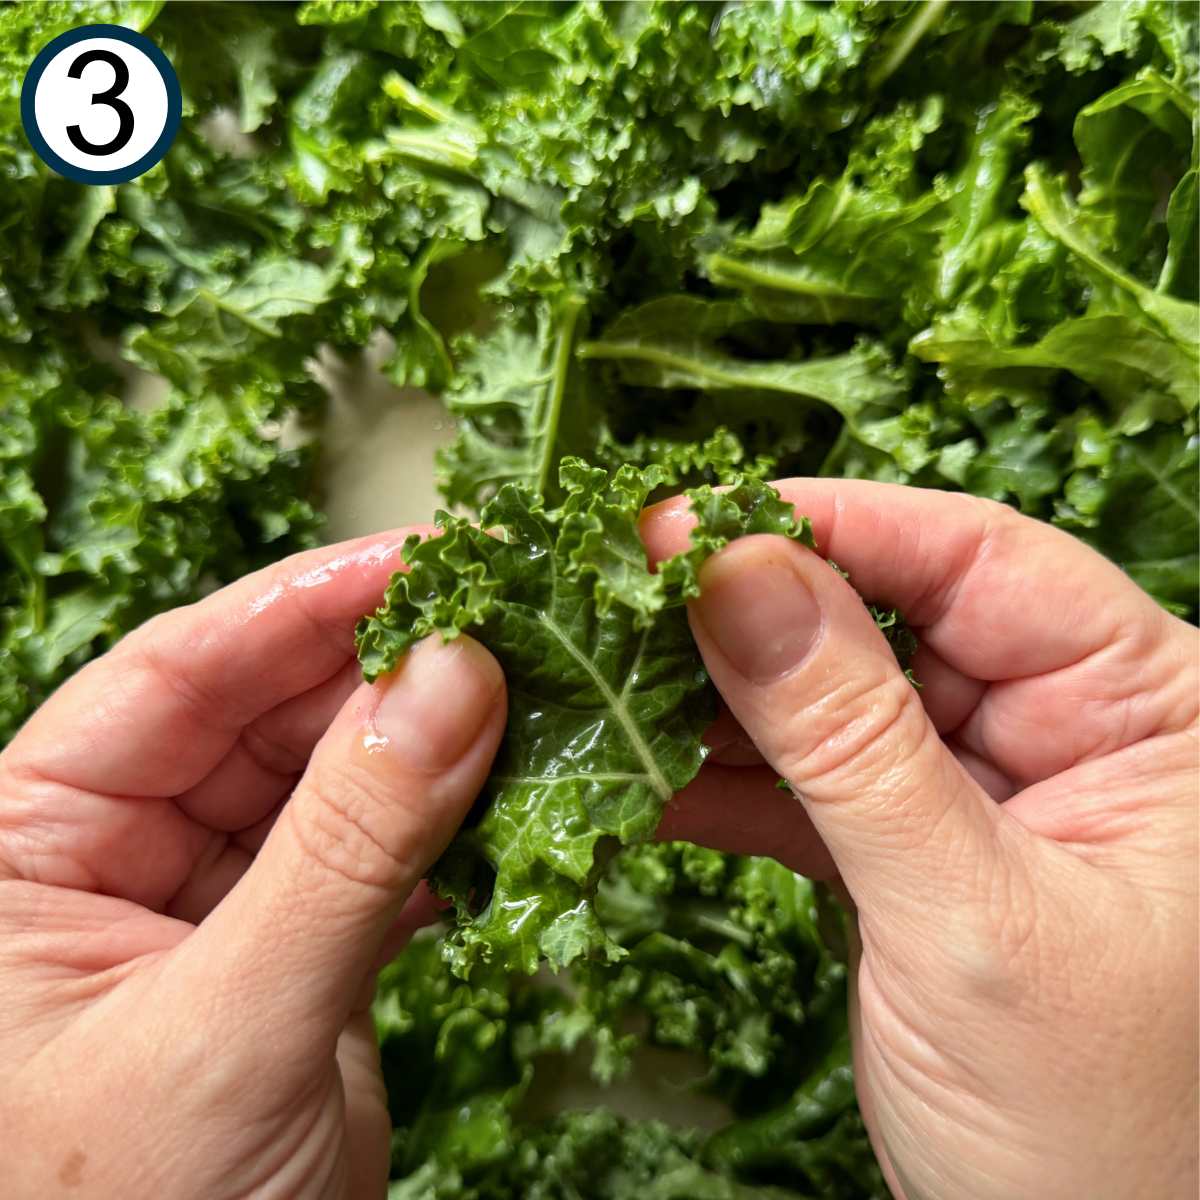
[0,0,1200,1200]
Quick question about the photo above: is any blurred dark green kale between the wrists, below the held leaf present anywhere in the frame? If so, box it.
[376,845,888,1200]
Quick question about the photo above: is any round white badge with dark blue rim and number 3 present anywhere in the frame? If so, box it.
[20,25,184,184]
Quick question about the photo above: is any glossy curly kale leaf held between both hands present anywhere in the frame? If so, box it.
[359,460,812,972]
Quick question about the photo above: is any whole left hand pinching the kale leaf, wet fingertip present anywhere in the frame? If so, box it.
[0,530,505,1200]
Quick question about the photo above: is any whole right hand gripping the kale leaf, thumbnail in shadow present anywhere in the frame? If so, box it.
[643,479,1198,1200]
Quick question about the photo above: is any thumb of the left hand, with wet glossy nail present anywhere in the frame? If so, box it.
[181,637,505,1045]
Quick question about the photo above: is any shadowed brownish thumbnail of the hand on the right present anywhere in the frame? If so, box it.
[692,538,821,683]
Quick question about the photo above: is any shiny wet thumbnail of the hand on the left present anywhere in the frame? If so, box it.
[373,636,504,772]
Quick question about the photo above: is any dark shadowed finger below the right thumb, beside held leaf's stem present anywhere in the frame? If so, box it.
[655,764,838,880]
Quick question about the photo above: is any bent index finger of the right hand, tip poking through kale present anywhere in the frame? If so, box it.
[642,479,1160,680]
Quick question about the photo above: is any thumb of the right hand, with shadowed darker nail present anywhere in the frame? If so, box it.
[690,536,998,916]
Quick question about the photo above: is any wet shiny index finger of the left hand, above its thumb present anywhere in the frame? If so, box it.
[6,529,436,797]
